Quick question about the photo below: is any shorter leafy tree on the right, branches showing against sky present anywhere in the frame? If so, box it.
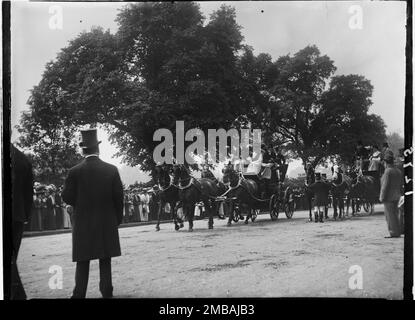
[245,46,385,166]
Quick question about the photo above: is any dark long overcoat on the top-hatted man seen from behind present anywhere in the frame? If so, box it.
[62,156,123,261]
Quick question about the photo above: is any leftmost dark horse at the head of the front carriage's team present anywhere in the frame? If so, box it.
[153,164,183,231]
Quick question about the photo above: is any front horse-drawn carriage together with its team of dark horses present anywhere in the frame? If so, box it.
[154,159,295,231]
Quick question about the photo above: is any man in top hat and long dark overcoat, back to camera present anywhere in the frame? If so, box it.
[62,129,123,299]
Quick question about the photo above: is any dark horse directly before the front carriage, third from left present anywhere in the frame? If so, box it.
[223,165,259,226]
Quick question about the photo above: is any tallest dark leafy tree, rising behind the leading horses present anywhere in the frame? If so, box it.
[116,3,250,168]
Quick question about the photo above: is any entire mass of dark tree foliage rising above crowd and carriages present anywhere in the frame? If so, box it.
[15,2,385,179]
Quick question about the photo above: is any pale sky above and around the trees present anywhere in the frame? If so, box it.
[11,1,406,183]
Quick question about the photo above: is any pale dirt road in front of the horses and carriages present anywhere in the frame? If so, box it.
[18,205,404,299]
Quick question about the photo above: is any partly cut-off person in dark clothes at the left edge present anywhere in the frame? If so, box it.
[10,145,33,300]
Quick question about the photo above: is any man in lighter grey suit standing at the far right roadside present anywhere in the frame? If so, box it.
[379,150,403,238]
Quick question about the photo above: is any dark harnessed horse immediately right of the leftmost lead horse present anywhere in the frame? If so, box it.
[173,164,223,231]
